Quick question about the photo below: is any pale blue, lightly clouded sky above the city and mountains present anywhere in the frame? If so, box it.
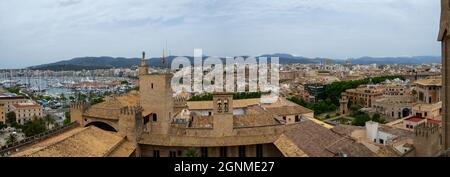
[0,0,440,69]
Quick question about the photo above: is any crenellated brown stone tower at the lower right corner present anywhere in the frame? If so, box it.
[414,123,441,157]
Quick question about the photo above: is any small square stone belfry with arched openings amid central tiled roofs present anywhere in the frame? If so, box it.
[213,93,233,136]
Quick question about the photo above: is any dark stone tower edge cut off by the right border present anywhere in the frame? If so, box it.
[438,0,450,151]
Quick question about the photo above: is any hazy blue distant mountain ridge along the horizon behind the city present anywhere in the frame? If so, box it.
[28,53,441,71]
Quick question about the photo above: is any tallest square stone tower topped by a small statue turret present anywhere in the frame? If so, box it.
[139,54,174,134]
